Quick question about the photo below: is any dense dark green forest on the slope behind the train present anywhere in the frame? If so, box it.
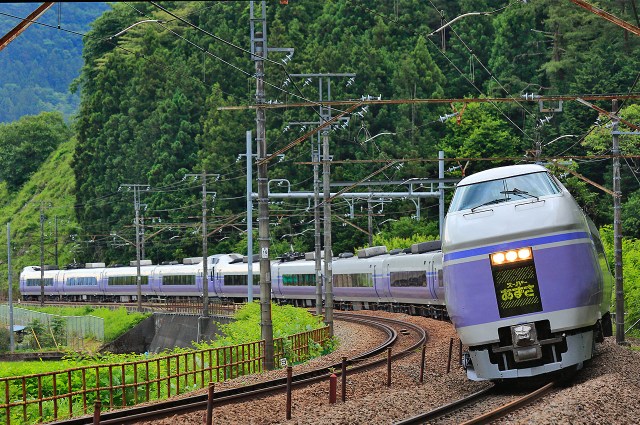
[0,0,640,328]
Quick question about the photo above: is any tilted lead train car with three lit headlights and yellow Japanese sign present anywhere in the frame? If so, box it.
[442,165,612,380]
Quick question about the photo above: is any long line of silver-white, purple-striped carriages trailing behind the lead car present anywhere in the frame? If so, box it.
[20,241,446,317]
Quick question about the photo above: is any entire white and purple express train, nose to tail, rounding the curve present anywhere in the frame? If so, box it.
[20,164,613,381]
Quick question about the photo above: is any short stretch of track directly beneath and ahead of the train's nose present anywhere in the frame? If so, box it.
[395,382,555,425]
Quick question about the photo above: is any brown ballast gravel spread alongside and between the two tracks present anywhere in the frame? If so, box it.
[135,311,640,425]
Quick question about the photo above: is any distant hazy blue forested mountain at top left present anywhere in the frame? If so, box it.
[0,2,108,122]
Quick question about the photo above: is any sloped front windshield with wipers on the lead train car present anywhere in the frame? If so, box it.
[449,172,560,212]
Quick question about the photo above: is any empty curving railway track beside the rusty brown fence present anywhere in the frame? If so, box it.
[55,312,427,425]
